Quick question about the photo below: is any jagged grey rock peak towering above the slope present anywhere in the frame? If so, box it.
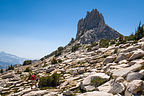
[76,9,119,44]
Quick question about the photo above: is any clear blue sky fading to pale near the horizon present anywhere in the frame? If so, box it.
[0,0,144,59]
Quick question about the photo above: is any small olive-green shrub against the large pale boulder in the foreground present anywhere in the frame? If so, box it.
[91,77,106,87]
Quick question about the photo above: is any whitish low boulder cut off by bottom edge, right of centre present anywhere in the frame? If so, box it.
[79,91,113,96]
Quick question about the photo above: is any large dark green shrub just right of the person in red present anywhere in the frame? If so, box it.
[38,73,60,88]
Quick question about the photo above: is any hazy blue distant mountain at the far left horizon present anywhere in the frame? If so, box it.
[0,52,26,69]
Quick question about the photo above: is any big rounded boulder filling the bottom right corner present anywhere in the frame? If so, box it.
[125,80,143,96]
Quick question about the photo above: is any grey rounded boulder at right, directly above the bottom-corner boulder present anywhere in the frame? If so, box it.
[126,72,143,81]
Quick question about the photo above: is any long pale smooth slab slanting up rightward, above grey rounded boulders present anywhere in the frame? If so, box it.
[112,64,142,78]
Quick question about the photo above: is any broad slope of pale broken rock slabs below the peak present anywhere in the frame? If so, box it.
[0,38,144,96]
